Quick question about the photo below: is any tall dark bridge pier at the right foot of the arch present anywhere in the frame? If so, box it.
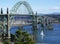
[32,12,37,41]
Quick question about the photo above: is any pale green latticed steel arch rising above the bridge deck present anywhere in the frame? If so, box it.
[10,1,34,15]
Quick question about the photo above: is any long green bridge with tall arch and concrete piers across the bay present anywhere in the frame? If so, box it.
[0,1,59,43]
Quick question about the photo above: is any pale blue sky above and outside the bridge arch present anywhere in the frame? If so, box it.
[0,0,60,13]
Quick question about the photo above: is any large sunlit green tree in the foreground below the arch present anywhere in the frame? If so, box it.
[11,30,34,44]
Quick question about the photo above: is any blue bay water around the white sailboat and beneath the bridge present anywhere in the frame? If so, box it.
[11,23,60,44]
